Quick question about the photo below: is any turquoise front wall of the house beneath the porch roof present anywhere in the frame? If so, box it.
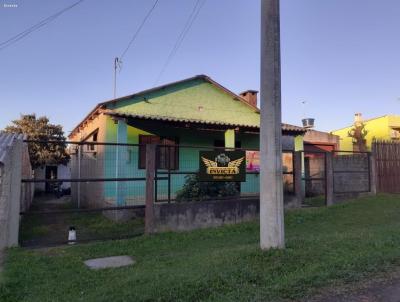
[99,118,259,204]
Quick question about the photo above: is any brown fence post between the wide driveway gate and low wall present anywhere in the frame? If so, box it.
[145,144,157,234]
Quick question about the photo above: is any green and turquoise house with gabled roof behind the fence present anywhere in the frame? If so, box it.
[69,75,305,207]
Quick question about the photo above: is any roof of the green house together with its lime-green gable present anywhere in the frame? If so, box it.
[69,75,306,137]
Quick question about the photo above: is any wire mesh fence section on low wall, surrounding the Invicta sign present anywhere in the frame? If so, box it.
[155,145,294,203]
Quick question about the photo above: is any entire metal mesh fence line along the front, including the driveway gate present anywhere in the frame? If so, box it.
[20,141,371,246]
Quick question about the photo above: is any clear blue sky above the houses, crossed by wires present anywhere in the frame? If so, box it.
[0,0,400,133]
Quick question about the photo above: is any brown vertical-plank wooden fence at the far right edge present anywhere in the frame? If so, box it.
[372,141,400,193]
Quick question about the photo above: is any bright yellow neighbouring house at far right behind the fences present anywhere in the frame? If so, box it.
[332,113,400,151]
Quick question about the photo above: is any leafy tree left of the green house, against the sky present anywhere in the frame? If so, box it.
[4,114,70,169]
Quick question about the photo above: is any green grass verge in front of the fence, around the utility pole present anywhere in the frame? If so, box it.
[0,195,400,302]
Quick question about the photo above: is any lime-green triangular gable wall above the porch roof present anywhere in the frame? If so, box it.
[106,78,260,127]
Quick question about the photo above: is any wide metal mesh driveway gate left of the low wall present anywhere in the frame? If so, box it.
[20,140,146,246]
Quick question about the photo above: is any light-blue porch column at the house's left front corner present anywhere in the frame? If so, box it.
[115,119,128,206]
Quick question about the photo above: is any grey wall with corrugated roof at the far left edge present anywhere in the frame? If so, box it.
[0,132,32,249]
